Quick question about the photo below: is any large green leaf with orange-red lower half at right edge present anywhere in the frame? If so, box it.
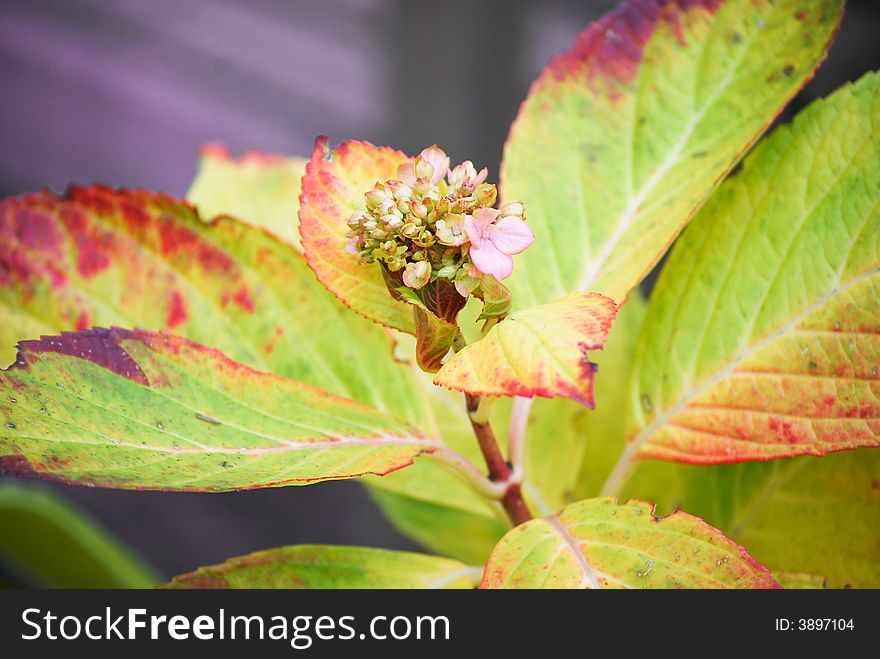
[628,74,880,463]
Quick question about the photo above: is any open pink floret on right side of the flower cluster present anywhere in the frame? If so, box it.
[464,208,535,281]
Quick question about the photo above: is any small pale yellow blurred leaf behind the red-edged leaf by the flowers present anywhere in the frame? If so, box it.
[186,144,308,249]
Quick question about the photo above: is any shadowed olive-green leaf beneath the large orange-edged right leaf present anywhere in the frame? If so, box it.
[624,449,880,588]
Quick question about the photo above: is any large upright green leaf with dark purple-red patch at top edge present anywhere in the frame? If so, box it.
[501,0,843,308]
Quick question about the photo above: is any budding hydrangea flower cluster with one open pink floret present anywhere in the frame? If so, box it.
[348,145,535,297]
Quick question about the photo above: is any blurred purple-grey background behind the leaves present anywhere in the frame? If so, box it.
[0,0,880,583]
